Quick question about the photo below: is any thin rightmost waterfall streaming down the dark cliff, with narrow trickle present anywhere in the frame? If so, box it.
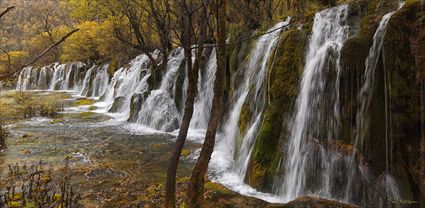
[345,2,404,201]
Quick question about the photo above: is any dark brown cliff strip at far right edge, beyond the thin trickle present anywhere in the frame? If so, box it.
[384,0,425,204]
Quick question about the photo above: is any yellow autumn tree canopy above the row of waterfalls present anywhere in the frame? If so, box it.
[0,0,284,84]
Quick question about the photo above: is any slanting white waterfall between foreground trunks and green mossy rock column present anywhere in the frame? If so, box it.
[213,17,291,182]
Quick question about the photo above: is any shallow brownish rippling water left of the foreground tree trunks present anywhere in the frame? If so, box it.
[0,92,199,207]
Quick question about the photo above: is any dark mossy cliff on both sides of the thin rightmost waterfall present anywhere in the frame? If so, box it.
[340,0,425,203]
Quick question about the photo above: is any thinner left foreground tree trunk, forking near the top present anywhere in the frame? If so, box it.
[165,0,206,208]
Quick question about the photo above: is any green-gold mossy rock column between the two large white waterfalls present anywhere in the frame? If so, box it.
[246,29,307,190]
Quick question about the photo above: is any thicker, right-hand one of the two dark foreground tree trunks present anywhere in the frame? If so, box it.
[186,0,227,208]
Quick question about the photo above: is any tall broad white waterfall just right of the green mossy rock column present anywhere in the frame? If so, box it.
[274,5,349,201]
